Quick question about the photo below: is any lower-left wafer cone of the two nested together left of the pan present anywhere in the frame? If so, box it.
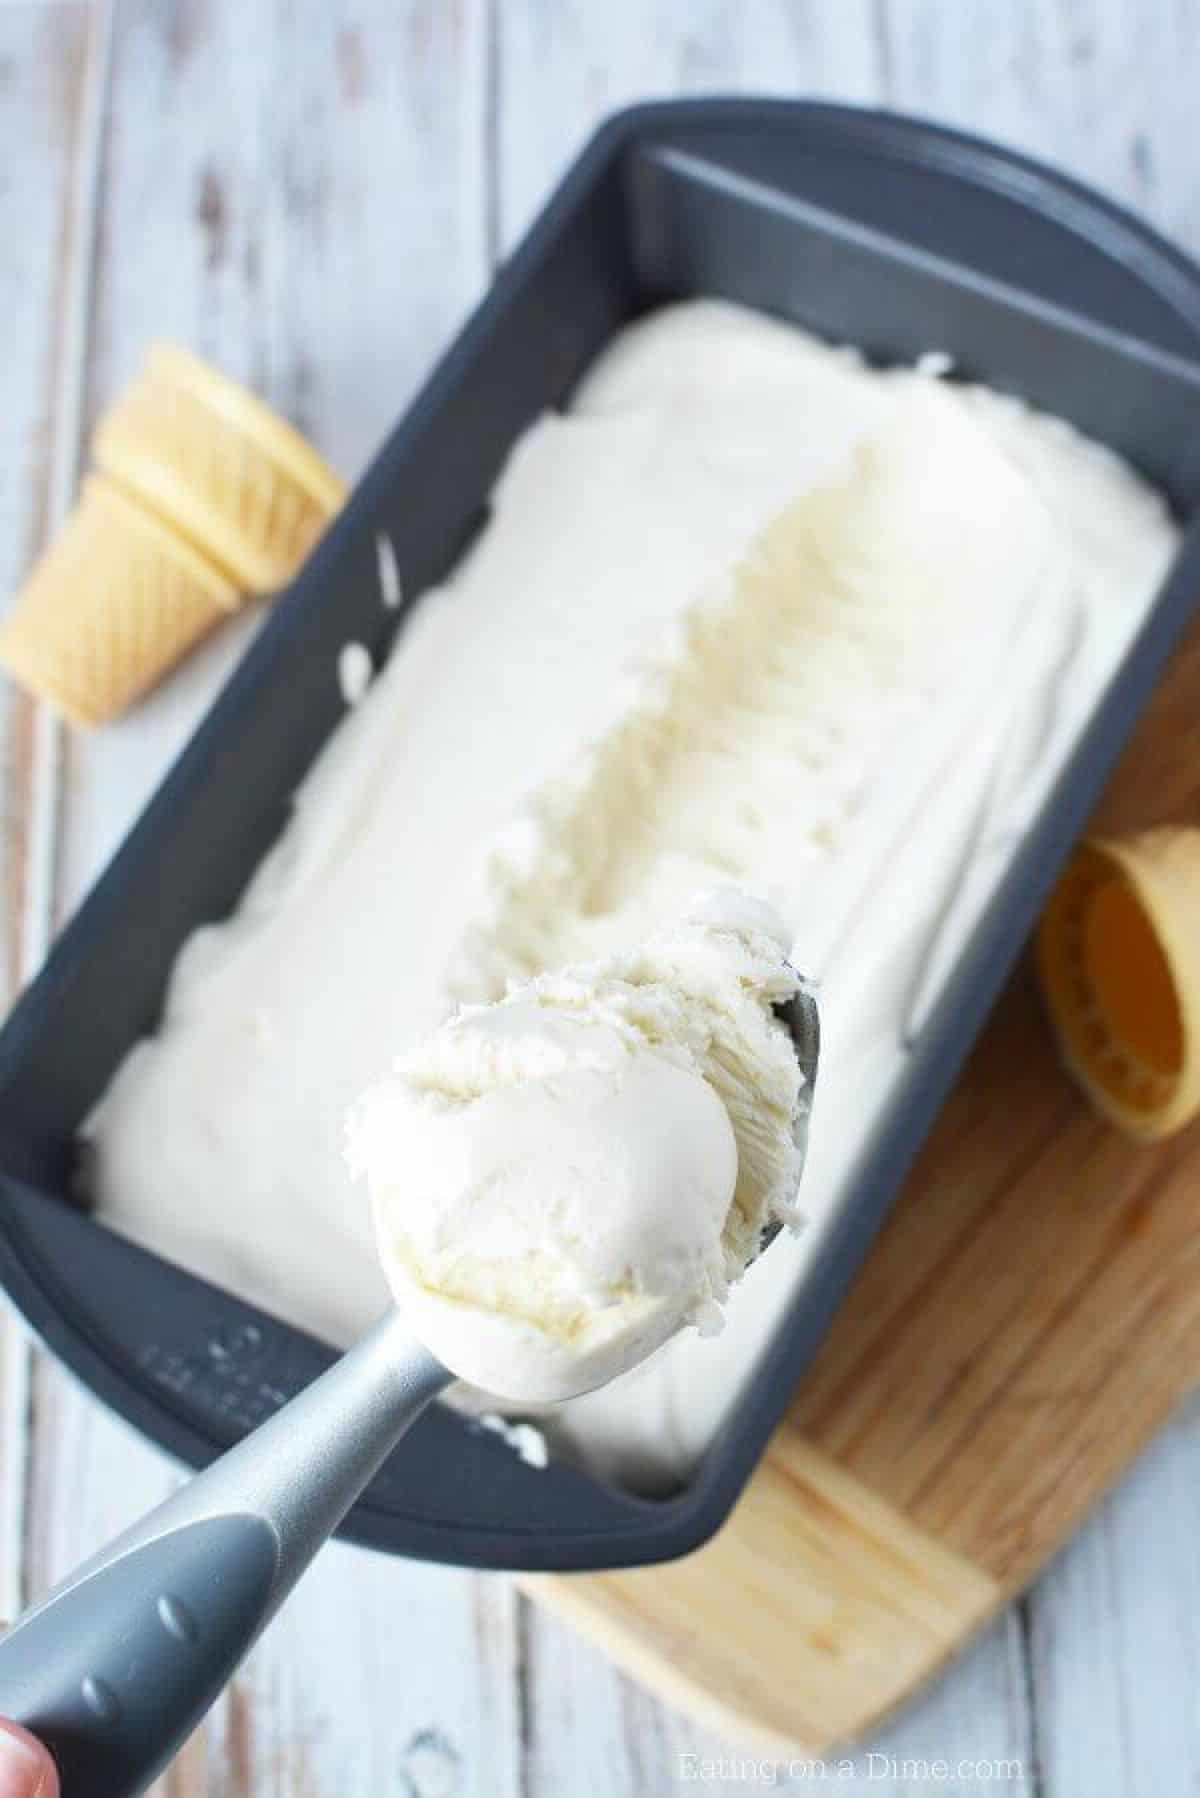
[0,475,239,725]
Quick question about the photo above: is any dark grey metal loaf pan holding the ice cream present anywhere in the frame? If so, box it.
[0,99,1200,1570]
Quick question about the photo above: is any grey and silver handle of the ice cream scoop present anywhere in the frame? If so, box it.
[0,1311,450,1798]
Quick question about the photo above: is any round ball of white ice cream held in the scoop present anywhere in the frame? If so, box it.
[347,894,806,1404]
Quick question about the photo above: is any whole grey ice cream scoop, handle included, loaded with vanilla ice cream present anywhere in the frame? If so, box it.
[0,913,819,1798]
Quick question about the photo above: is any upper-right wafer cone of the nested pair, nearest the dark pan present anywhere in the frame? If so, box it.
[92,343,345,593]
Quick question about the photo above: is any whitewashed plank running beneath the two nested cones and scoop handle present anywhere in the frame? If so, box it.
[31,0,520,1798]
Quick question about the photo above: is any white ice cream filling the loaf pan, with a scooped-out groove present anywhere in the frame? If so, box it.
[90,302,1175,1483]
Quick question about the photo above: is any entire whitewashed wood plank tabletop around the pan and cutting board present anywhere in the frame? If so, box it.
[0,0,1200,1798]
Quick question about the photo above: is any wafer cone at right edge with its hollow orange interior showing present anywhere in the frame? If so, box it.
[1038,827,1200,1140]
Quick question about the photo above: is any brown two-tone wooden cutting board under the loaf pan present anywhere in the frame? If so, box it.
[522,626,1200,1755]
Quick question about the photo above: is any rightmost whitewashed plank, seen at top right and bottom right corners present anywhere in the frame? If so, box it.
[883,0,1200,1798]
